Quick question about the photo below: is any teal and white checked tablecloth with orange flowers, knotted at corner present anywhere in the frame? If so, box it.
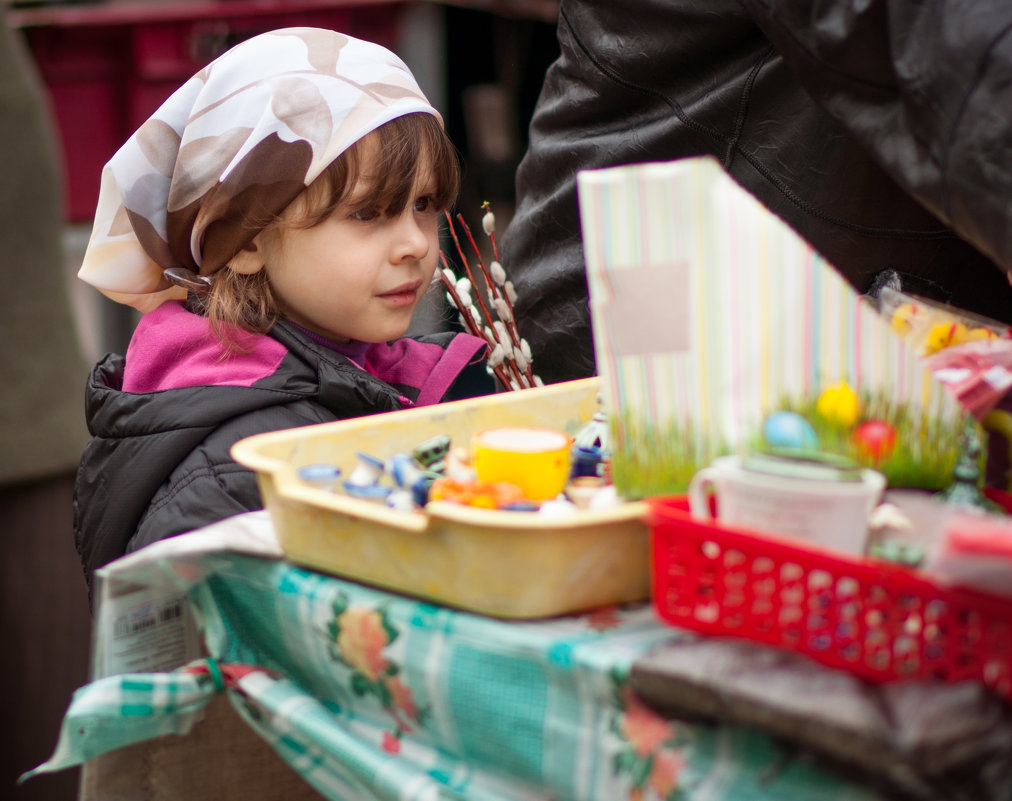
[25,513,876,801]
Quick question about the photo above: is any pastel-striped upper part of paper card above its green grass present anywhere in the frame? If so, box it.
[578,157,962,497]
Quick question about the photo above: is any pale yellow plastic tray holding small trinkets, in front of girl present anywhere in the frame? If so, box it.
[232,378,650,618]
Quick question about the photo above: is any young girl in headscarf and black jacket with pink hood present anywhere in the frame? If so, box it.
[75,28,494,585]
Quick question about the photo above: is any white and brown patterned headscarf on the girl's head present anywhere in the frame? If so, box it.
[78,27,439,312]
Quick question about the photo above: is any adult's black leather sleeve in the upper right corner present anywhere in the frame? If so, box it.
[741,0,1012,270]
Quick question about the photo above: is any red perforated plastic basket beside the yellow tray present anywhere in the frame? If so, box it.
[649,497,1012,698]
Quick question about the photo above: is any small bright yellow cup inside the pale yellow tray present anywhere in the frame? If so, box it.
[472,427,573,501]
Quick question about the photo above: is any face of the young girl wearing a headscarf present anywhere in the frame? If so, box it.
[263,145,440,342]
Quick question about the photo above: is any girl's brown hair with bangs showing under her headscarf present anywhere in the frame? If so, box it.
[197,113,459,351]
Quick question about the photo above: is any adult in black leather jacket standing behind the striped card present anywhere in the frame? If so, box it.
[502,0,1012,381]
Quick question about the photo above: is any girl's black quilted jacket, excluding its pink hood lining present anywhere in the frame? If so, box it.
[74,313,495,589]
